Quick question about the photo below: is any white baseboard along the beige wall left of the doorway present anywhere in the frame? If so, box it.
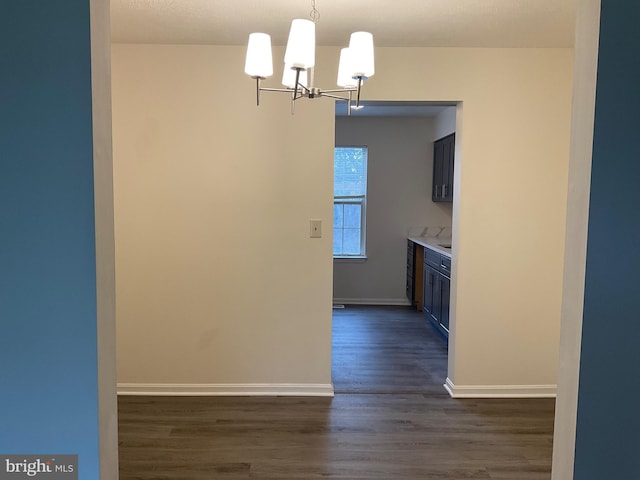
[118,383,334,397]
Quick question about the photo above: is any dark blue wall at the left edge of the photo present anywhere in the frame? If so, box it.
[0,0,98,479]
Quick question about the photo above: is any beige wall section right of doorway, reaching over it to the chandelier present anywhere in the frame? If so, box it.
[360,49,572,394]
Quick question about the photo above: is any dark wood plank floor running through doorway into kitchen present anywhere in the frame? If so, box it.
[119,307,554,480]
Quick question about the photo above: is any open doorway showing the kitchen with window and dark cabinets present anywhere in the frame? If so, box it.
[333,101,457,392]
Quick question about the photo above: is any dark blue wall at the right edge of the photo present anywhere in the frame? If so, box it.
[567,0,640,480]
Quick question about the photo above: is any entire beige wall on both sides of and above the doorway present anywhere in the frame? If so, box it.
[113,45,572,394]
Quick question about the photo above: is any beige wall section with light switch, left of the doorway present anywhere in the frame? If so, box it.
[113,45,334,392]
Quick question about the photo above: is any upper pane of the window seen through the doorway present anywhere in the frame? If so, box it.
[333,147,367,197]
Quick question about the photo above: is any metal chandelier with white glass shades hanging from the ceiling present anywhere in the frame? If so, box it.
[244,0,375,115]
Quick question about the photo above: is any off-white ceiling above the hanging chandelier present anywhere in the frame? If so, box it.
[111,0,578,47]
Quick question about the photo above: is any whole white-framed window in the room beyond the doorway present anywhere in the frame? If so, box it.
[333,147,367,257]
